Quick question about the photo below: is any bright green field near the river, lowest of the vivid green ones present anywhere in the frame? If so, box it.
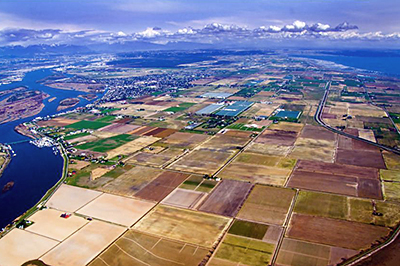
[76,134,138,152]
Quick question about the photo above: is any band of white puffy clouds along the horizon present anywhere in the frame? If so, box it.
[0,20,400,46]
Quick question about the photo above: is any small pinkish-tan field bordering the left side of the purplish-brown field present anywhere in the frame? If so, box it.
[162,188,206,209]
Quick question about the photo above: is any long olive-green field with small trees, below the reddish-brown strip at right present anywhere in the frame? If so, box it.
[294,190,400,226]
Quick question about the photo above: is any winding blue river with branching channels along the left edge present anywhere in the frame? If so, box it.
[0,69,98,228]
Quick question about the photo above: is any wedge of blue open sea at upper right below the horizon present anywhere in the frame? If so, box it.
[301,55,400,77]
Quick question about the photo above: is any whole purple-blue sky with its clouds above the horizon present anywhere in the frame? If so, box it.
[0,0,400,46]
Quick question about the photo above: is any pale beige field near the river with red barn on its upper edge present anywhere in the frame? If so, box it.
[26,209,88,241]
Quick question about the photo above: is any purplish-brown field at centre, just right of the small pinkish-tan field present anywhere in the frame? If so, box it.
[199,180,252,217]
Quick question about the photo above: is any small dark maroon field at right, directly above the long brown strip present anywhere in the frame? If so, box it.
[336,148,386,169]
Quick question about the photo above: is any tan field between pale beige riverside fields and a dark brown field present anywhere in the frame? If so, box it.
[98,166,163,197]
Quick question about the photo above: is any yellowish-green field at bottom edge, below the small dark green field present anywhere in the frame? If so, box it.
[215,235,275,266]
